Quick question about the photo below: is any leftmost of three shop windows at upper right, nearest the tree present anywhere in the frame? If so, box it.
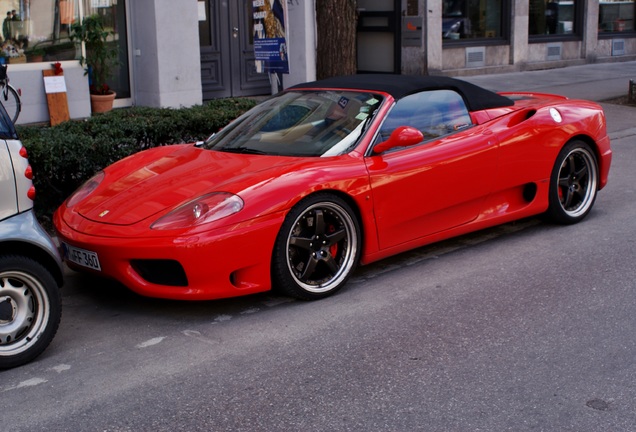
[442,0,505,40]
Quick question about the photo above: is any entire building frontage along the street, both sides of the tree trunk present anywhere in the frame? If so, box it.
[0,0,636,123]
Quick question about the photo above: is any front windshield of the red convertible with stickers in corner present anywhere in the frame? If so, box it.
[203,90,382,156]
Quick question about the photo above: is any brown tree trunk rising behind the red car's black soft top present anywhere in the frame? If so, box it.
[316,0,358,79]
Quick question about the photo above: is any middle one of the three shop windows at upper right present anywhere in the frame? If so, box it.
[528,0,582,36]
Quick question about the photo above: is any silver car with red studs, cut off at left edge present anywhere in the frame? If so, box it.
[0,105,63,369]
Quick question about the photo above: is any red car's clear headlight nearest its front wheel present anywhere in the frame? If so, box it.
[150,192,243,230]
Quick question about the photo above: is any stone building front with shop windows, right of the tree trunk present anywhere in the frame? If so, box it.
[358,0,636,76]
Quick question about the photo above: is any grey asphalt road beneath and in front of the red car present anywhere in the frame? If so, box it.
[0,105,636,432]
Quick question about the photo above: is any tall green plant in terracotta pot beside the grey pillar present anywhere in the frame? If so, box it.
[69,15,119,112]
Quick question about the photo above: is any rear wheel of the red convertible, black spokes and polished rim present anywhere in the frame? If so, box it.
[547,140,598,224]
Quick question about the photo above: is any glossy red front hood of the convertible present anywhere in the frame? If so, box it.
[74,145,297,225]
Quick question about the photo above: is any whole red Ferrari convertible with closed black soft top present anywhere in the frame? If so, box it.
[54,75,612,300]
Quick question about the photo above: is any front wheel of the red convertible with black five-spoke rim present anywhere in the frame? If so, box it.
[272,193,361,300]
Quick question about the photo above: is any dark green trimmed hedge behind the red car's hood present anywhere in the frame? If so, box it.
[17,99,256,227]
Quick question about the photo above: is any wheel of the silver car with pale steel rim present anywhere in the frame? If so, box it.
[0,255,62,369]
